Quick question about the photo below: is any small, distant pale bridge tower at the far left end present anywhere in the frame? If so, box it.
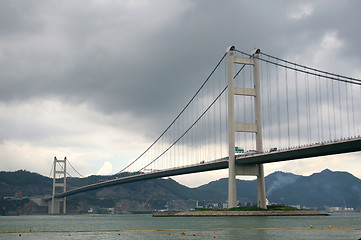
[48,157,66,214]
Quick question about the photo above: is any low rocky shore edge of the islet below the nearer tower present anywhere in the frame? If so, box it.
[152,210,329,217]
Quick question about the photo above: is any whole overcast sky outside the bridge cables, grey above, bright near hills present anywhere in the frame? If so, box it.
[0,0,361,186]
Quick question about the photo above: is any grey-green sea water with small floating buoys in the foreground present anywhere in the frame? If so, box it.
[0,213,361,240]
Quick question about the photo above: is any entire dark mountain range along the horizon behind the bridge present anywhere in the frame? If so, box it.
[0,169,361,213]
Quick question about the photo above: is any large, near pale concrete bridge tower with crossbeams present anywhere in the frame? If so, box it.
[227,46,267,208]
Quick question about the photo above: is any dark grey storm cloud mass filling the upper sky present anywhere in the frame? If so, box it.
[0,1,361,135]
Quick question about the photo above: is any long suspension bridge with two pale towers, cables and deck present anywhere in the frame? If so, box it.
[45,46,361,214]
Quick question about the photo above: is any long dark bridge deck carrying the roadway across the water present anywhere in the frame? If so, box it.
[52,136,361,200]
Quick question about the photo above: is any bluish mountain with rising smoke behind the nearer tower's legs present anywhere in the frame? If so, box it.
[198,169,361,209]
